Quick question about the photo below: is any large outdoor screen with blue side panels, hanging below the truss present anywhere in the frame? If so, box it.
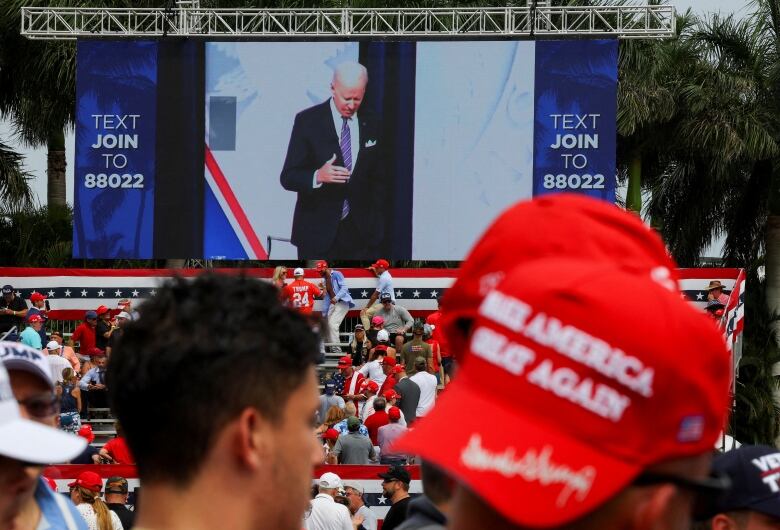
[74,40,617,260]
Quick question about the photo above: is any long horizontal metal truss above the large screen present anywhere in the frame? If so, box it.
[21,1,676,39]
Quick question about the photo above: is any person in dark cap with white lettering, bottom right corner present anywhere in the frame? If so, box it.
[692,445,780,530]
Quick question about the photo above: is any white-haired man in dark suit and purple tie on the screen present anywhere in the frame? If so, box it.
[280,62,386,259]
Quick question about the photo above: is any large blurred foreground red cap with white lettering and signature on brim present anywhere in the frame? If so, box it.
[395,259,731,528]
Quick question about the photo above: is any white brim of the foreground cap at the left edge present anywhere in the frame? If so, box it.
[0,418,87,464]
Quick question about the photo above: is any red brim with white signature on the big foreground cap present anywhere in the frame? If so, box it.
[394,383,641,528]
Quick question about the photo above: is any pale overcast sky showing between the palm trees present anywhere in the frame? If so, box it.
[0,0,750,204]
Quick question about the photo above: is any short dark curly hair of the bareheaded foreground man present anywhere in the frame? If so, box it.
[107,274,319,486]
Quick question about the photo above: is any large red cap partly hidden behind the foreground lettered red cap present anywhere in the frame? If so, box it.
[442,193,678,358]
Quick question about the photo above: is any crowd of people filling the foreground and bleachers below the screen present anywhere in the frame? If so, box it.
[0,194,760,530]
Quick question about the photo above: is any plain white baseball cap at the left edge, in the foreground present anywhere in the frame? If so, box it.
[0,342,87,464]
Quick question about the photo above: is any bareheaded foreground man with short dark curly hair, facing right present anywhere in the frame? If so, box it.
[108,274,322,530]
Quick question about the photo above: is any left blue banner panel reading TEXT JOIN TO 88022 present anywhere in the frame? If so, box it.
[73,41,158,259]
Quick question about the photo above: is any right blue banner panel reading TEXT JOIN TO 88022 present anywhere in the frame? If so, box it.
[534,40,618,202]
